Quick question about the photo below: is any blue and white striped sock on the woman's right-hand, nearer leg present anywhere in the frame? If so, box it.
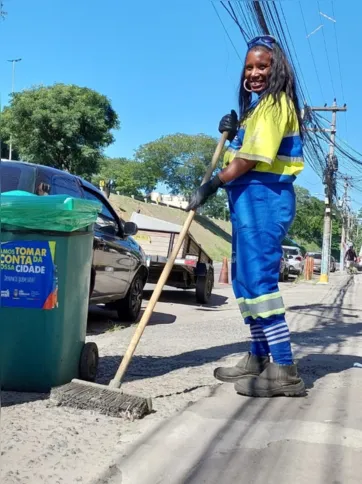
[263,321,293,365]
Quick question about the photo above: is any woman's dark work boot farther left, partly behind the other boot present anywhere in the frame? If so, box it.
[214,353,270,383]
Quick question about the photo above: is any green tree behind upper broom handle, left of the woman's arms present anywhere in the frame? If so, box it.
[135,133,217,195]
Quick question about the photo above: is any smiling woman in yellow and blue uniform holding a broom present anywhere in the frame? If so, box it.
[187,35,305,397]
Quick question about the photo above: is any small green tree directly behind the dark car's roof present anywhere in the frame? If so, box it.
[93,158,157,196]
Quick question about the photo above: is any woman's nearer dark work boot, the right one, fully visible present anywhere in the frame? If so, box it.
[235,363,305,397]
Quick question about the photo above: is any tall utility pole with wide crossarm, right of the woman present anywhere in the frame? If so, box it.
[308,99,347,284]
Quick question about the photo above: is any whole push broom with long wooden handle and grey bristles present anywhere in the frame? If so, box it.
[50,133,228,420]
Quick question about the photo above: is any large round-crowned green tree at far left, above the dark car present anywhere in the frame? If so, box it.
[1,84,119,177]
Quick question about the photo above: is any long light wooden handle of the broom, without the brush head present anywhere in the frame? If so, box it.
[109,132,228,388]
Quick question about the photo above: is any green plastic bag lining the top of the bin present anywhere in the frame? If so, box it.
[0,191,102,232]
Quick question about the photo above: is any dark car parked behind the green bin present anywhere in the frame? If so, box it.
[0,161,148,321]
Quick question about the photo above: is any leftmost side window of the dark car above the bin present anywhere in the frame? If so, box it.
[0,162,35,193]
